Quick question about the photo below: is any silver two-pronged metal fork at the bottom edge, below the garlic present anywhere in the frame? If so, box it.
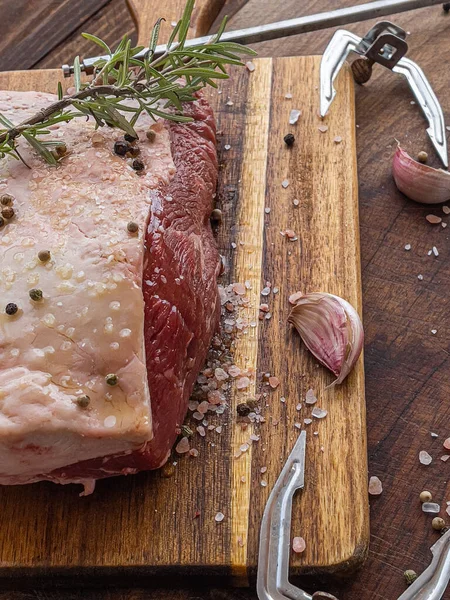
[257,431,450,600]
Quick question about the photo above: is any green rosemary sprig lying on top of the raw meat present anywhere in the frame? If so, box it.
[0,0,255,166]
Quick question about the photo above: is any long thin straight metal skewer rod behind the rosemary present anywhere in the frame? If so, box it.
[62,0,442,77]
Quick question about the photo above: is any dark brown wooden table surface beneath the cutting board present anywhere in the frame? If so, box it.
[0,0,450,600]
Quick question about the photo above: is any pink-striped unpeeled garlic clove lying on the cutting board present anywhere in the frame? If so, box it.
[288,292,364,387]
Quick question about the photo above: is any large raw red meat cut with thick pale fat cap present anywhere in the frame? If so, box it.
[0,92,220,491]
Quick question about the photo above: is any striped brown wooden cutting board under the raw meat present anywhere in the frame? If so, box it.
[0,0,369,585]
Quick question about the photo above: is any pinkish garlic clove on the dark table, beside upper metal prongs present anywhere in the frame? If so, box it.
[392,144,450,204]
